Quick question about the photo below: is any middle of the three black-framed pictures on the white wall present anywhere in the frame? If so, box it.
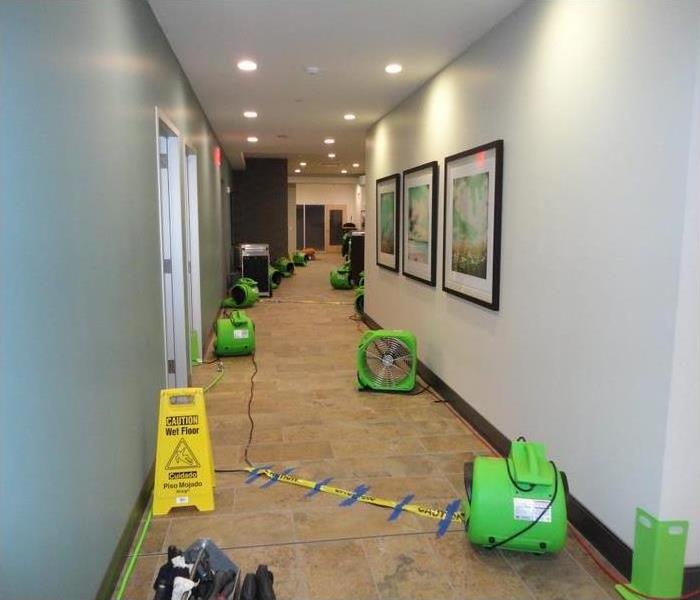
[401,160,439,287]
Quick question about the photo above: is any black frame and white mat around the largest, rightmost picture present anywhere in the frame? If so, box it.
[442,140,503,311]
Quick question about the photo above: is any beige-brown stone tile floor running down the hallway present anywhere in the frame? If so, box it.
[119,255,617,600]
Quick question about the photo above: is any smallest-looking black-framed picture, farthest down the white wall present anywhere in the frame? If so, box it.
[375,173,401,273]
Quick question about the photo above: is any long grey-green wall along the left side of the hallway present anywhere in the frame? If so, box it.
[0,0,228,600]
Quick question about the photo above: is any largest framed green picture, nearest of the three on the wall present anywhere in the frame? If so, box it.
[442,140,503,311]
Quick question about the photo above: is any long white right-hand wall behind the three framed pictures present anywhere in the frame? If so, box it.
[365,0,700,562]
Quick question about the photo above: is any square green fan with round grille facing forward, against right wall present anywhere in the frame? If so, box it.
[357,329,418,392]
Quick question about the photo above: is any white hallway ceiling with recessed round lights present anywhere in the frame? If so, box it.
[149,0,522,175]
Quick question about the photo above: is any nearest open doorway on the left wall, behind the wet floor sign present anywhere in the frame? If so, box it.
[156,107,189,387]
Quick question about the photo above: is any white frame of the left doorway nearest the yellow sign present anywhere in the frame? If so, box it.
[155,106,190,387]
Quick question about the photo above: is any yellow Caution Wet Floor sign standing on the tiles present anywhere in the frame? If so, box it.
[153,388,215,515]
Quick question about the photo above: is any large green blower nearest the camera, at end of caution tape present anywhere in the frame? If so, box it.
[464,438,569,554]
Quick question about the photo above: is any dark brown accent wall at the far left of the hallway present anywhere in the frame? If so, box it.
[231,158,288,260]
